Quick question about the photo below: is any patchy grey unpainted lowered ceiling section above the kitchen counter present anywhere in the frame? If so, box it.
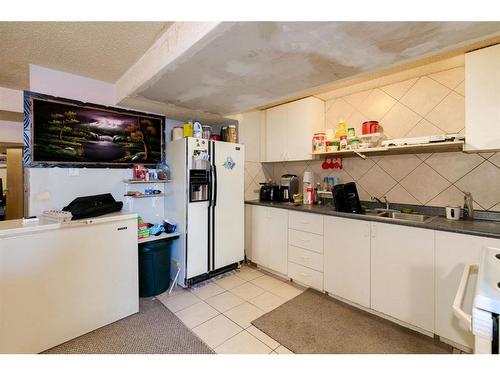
[134,22,500,115]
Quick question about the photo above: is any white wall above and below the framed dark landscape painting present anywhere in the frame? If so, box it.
[25,65,164,222]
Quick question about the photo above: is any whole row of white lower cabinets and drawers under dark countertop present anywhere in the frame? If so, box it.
[245,205,500,348]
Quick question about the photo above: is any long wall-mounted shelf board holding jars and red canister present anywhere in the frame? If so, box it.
[312,141,464,157]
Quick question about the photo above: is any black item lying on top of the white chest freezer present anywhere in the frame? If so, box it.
[63,193,123,220]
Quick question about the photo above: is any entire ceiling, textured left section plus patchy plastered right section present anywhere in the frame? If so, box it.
[0,22,500,123]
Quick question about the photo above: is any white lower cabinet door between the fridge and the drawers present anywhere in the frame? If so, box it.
[245,205,288,275]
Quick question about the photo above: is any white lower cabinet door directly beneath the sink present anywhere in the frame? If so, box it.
[371,223,434,332]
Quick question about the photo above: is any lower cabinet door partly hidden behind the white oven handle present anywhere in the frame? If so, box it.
[436,232,500,348]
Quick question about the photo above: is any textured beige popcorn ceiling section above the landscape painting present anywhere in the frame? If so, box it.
[0,22,171,90]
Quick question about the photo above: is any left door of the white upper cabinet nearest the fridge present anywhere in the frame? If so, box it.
[265,105,287,161]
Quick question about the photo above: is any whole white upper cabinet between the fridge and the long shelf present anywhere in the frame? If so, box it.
[264,97,325,162]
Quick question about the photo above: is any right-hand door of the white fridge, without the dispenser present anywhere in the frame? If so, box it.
[213,142,245,269]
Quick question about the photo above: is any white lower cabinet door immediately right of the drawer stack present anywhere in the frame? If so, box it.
[324,217,370,307]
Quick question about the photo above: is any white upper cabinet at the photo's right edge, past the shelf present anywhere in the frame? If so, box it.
[465,44,500,151]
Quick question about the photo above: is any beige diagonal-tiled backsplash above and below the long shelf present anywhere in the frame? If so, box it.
[245,66,500,211]
